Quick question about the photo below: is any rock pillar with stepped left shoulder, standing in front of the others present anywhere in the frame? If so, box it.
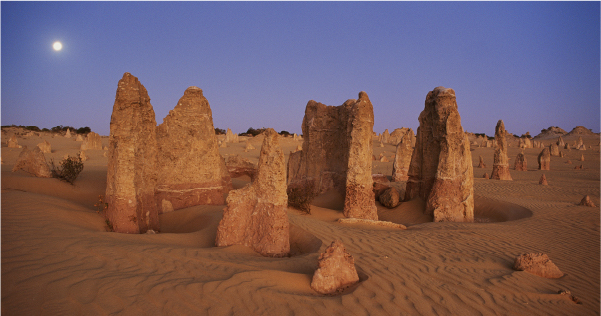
[215,128,290,257]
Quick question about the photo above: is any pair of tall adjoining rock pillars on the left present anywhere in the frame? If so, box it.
[106,73,231,233]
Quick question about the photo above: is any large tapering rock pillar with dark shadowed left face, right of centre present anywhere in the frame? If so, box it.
[405,87,474,222]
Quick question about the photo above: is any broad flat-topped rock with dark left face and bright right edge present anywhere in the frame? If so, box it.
[292,92,377,219]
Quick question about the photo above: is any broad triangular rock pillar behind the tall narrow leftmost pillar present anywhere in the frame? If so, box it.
[155,87,232,210]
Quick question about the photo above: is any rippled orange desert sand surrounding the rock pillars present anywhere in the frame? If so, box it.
[1,128,600,315]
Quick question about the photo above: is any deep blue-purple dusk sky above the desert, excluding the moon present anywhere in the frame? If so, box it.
[1,2,601,135]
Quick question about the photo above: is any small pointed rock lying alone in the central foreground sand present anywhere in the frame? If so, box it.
[311,240,359,294]
